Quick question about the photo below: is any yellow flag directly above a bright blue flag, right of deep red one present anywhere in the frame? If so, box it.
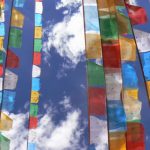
[119,37,136,61]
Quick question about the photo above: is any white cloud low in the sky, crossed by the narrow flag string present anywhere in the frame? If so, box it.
[4,96,86,150]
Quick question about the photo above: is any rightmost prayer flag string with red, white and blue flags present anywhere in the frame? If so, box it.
[126,1,150,102]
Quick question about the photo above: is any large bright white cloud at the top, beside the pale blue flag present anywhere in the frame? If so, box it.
[44,0,85,67]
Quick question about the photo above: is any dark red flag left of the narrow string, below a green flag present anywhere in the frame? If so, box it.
[6,50,19,68]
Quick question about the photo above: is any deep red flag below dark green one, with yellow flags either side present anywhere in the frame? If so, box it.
[102,43,121,68]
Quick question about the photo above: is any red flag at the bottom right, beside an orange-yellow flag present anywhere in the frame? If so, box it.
[126,122,145,150]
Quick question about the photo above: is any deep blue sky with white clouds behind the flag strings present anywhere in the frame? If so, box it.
[1,0,150,150]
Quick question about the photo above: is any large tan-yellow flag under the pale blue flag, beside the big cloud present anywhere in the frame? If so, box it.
[86,34,102,59]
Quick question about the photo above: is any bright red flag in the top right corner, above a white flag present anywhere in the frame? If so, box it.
[126,4,148,25]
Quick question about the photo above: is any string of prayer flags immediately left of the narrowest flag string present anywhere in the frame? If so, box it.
[0,0,25,150]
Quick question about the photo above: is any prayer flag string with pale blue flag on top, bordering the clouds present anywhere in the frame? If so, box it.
[84,0,108,149]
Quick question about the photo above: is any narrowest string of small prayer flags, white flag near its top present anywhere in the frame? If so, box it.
[28,0,43,150]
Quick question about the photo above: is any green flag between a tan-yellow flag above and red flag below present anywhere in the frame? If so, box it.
[87,61,105,86]
